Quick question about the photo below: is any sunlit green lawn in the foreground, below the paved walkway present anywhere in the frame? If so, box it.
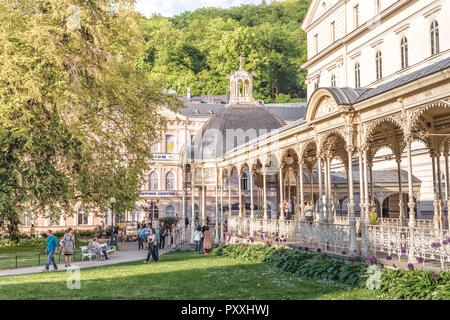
[0,252,377,299]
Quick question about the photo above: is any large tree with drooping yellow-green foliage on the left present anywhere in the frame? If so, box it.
[0,0,180,238]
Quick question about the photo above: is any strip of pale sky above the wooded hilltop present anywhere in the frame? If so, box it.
[136,0,270,17]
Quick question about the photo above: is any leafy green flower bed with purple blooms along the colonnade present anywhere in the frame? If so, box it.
[212,242,450,299]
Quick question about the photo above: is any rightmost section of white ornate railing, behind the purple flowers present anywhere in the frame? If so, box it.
[367,225,450,268]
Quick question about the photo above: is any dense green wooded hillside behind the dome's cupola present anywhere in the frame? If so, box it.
[143,0,310,102]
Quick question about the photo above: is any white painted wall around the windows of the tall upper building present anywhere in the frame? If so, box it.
[307,0,450,98]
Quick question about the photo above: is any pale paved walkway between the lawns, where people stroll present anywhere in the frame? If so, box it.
[0,243,188,276]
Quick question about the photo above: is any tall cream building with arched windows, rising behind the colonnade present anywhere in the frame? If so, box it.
[302,0,450,218]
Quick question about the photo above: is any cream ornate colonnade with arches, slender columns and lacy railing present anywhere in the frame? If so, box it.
[181,61,450,263]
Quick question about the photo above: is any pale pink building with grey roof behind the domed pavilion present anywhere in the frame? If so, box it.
[135,90,306,223]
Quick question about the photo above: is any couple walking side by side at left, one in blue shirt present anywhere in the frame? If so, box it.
[44,228,75,271]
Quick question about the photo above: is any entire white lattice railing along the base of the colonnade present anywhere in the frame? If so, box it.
[228,216,450,268]
